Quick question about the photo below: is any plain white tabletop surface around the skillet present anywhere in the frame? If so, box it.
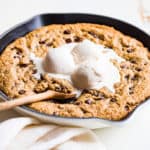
[0,0,150,150]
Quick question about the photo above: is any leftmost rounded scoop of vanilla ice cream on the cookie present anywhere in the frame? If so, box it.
[43,43,75,74]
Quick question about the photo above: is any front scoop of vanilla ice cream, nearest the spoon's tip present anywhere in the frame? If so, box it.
[71,59,101,89]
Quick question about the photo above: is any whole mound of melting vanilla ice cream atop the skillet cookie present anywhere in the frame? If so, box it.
[30,40,124,92]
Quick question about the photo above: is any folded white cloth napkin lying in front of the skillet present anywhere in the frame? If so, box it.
[0,117,106,150]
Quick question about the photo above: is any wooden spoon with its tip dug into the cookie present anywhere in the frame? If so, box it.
[0,90,76,111]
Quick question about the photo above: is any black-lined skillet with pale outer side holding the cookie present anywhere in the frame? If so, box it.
[0,13,150,128]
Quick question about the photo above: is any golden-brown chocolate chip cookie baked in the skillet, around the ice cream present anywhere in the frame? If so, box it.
[0,23,150,120]
